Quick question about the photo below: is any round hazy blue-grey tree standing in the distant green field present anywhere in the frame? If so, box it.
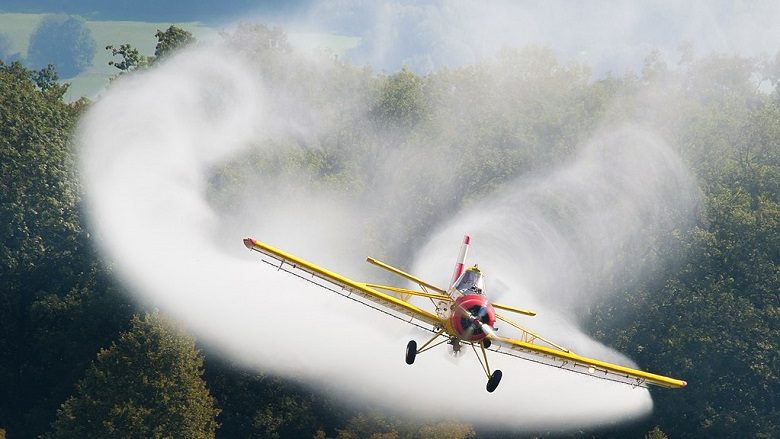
[27,15,95,78]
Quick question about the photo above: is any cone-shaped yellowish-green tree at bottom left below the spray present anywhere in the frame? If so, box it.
[47,313,219,438]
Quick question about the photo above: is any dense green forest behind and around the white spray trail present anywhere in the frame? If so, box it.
[0,24,780,439]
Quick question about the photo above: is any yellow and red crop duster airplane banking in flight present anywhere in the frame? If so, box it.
[244,235,688,392]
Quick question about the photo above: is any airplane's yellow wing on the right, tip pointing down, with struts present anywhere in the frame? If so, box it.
[491,317,688,388]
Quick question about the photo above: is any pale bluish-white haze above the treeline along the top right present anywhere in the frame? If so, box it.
[295,0,780,77]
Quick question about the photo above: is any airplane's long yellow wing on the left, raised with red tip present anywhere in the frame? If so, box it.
[244,238,442,325]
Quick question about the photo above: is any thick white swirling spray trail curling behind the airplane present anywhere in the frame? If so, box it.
[80,21,693,436]
